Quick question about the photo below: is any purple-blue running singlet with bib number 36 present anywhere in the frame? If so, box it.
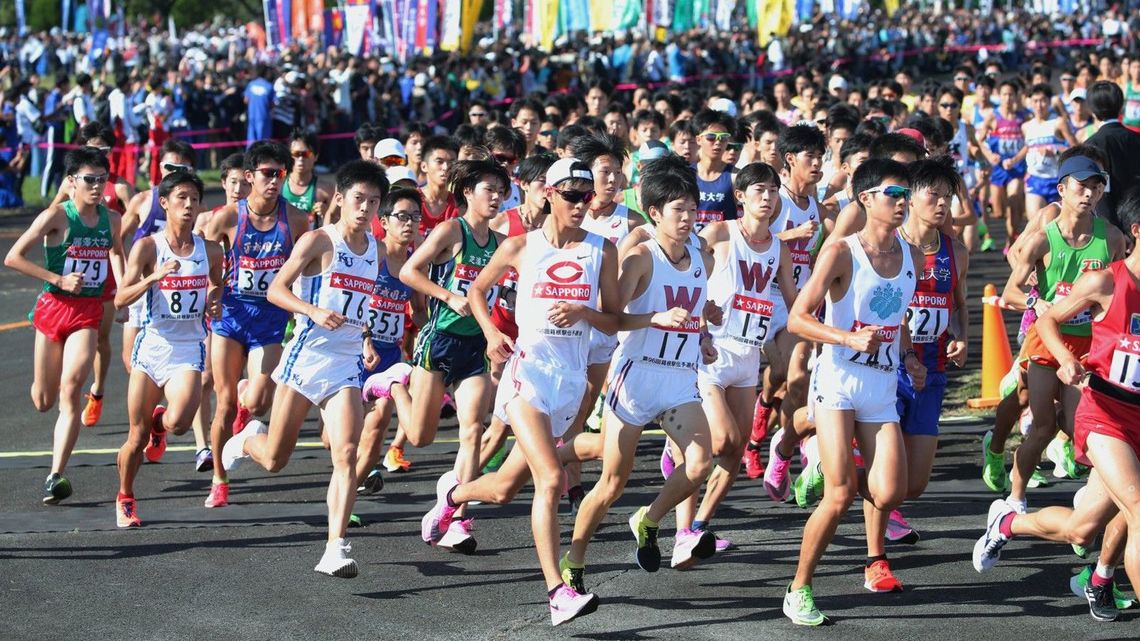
[222,198,293,307]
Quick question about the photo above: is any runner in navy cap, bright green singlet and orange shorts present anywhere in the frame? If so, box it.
[1002,156,1124,512]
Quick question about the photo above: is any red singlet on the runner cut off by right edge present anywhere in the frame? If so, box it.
[1085,260,1140,393]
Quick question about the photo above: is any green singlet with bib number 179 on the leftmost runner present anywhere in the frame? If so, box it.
[43,200,112,297]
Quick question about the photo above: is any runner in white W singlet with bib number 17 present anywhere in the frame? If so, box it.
[562,149,716,593]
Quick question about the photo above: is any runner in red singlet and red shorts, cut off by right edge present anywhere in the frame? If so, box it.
[974,188,1140,620]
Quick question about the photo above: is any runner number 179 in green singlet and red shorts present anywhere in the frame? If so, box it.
[5,147,123,505]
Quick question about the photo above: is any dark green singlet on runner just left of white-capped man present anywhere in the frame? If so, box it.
[428,218,498,336]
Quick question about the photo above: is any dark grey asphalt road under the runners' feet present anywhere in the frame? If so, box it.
[0,226,1140,641]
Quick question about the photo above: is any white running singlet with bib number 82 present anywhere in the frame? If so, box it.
[143,234,210,342]
